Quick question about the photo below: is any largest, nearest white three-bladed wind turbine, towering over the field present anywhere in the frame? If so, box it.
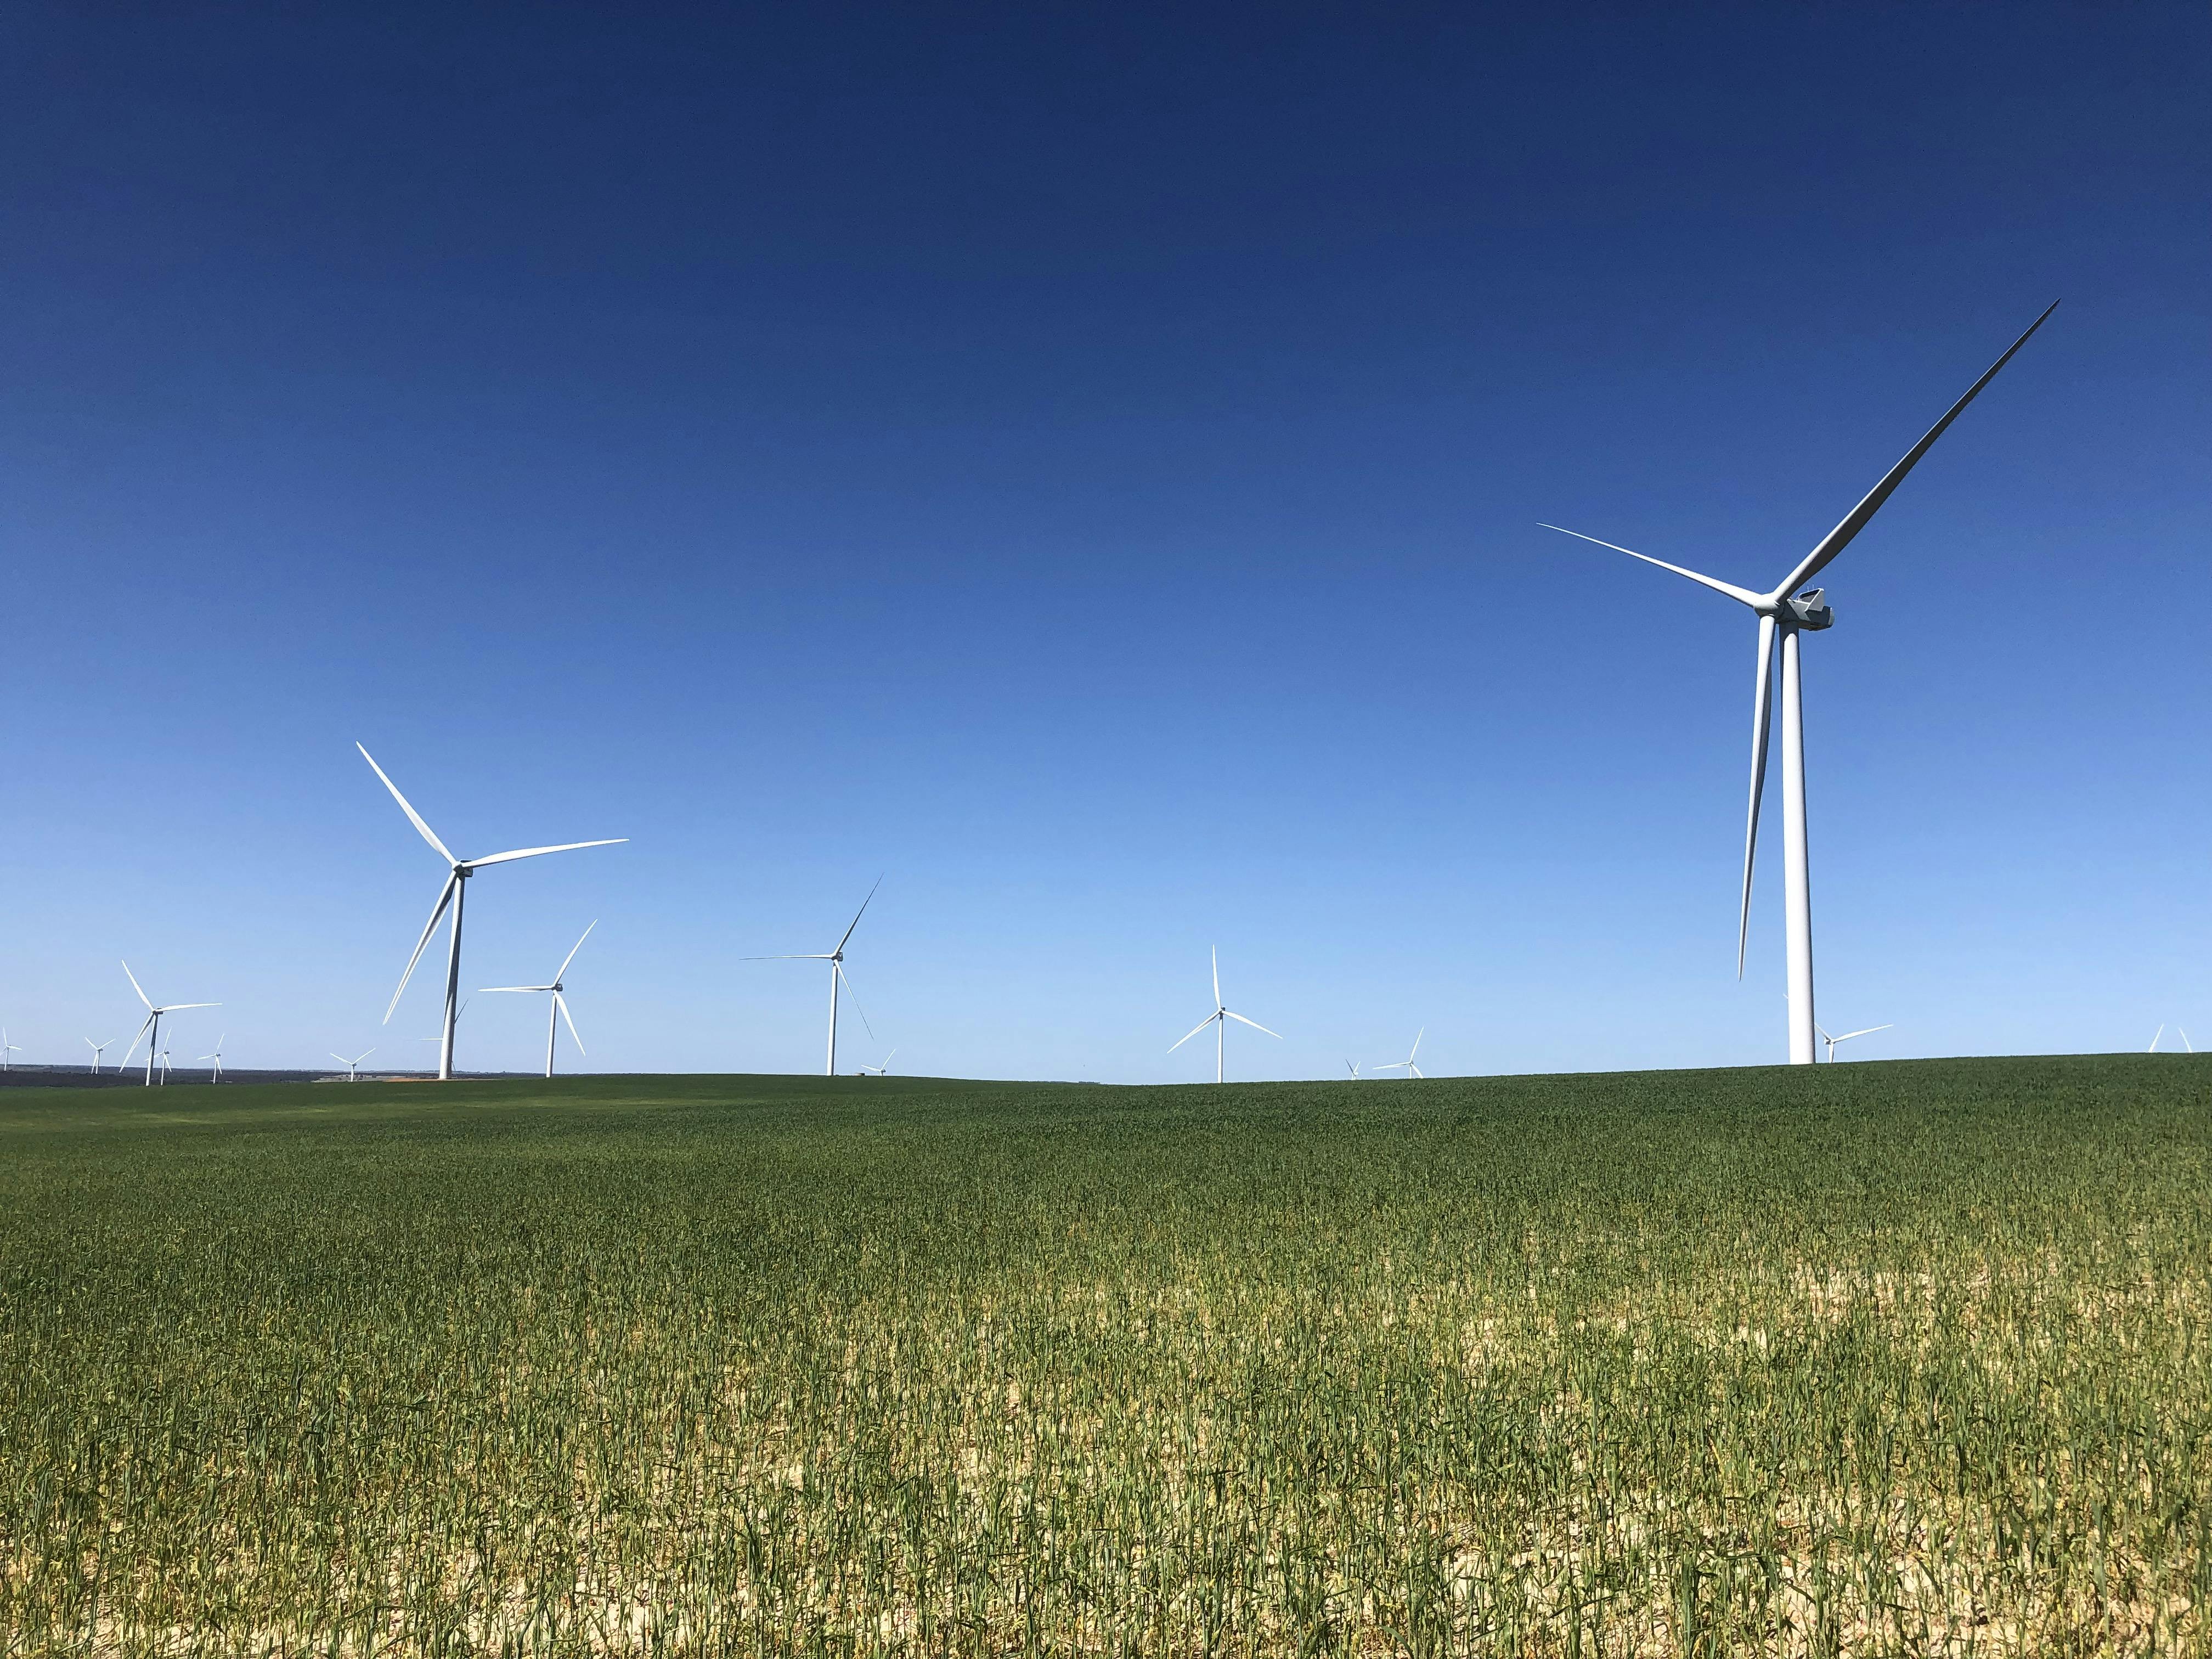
[1542,301,2057,1066]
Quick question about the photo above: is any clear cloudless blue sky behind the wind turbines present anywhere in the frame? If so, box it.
[0,4,2212,1082]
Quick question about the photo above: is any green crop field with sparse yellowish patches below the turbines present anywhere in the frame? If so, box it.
[0,1055,2212,1655]
